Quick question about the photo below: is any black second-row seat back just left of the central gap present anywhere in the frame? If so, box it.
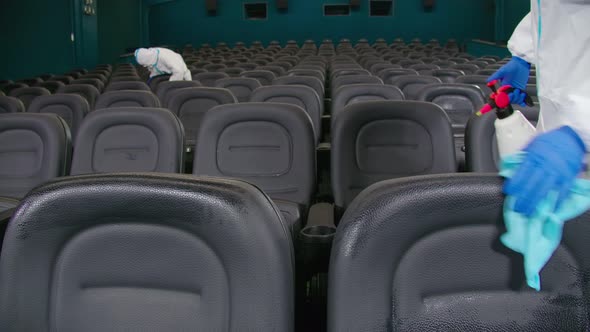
[193,103,315,206]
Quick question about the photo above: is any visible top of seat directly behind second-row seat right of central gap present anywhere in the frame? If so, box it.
[332,84,405,120]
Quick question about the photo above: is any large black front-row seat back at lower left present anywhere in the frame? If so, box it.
[0,174,295,332]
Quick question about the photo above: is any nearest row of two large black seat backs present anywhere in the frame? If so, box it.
[0,174,590,332]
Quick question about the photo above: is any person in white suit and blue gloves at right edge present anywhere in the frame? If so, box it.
[490,0,590,216]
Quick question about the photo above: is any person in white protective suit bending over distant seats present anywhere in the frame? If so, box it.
[135,47,192,81]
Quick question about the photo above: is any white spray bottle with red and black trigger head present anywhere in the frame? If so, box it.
[477,81,536,158]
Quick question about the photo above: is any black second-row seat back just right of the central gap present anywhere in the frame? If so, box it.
[331,101,457,208]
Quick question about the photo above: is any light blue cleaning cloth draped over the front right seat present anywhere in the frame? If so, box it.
[500,153,590,291]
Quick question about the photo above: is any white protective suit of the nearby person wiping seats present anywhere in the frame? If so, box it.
[508,0,590,147]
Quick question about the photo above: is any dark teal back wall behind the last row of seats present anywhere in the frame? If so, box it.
[149,0,495,44]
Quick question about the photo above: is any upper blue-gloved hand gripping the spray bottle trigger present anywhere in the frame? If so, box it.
[488,56,531,106]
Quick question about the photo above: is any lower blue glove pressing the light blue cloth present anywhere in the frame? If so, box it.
[504,126,586,217]
